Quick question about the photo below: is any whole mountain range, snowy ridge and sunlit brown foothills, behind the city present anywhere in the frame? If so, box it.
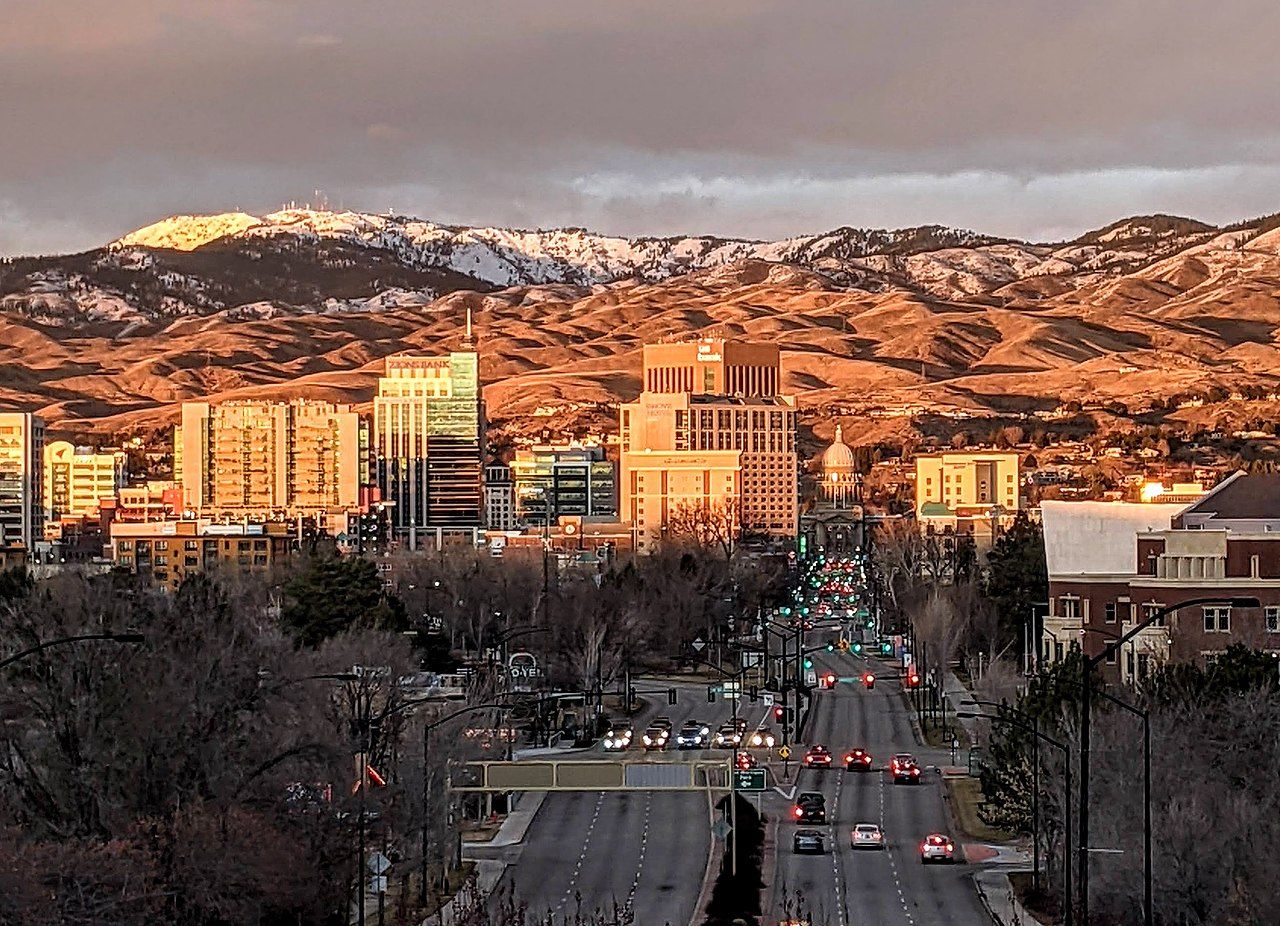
[0,209,1280,448]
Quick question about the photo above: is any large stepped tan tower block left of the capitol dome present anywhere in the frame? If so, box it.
[620,338,799,552]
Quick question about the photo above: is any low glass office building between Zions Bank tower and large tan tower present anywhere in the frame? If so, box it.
[511,442,618,524]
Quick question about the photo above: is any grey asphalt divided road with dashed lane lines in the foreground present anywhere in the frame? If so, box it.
[483,653,989,926]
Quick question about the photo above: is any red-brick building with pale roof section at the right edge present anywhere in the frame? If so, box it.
[1039,473,1280,681]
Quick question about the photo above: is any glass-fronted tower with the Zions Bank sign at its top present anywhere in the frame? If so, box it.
[374,350,484,547]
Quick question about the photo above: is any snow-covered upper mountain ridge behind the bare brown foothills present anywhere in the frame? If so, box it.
[0,207,1256,327]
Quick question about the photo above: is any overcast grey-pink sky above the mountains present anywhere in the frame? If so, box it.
[0,0,1280,254]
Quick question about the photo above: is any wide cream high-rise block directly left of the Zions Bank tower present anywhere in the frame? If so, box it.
[174,400,369,523]
